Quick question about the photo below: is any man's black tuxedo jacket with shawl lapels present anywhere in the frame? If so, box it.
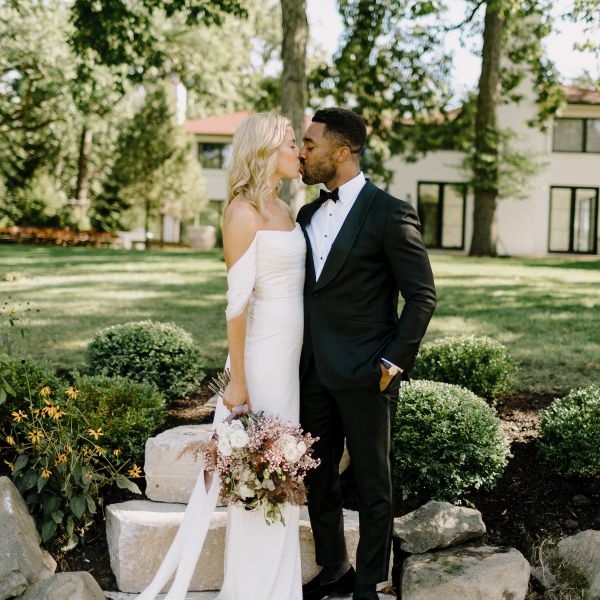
[297,181,436,390]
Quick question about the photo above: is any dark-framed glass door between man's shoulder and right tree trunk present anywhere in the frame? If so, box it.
[417,182,467,249]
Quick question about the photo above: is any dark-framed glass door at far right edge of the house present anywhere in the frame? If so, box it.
[548,187,598,254]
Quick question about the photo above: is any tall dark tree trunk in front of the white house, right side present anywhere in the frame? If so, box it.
[470,0,504,256]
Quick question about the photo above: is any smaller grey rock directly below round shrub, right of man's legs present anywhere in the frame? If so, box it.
[394,501,485,554]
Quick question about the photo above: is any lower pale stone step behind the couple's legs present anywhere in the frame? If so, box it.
[106,500,380,592]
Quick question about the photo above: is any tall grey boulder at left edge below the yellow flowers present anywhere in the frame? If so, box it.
[0,477,56,600]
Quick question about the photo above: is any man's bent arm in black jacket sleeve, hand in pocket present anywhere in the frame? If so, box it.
[382,199,437,371]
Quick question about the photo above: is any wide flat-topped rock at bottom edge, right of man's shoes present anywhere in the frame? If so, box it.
[402,546,530,600]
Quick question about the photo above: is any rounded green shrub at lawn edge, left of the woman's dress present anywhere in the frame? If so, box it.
[87,320,204,398]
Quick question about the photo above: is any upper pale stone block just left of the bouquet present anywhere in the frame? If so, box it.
[144,425,212,504]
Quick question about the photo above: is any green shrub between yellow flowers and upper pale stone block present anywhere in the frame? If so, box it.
[75,375,165,463]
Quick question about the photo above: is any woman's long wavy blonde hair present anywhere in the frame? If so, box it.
[225,112,291,218]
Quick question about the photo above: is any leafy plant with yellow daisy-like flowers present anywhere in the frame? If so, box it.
[0,386,141,551]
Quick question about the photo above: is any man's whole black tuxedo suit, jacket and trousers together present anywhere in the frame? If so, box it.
[298,181,436,584]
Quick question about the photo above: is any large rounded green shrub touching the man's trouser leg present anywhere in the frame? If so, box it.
[393,381,510,501]
